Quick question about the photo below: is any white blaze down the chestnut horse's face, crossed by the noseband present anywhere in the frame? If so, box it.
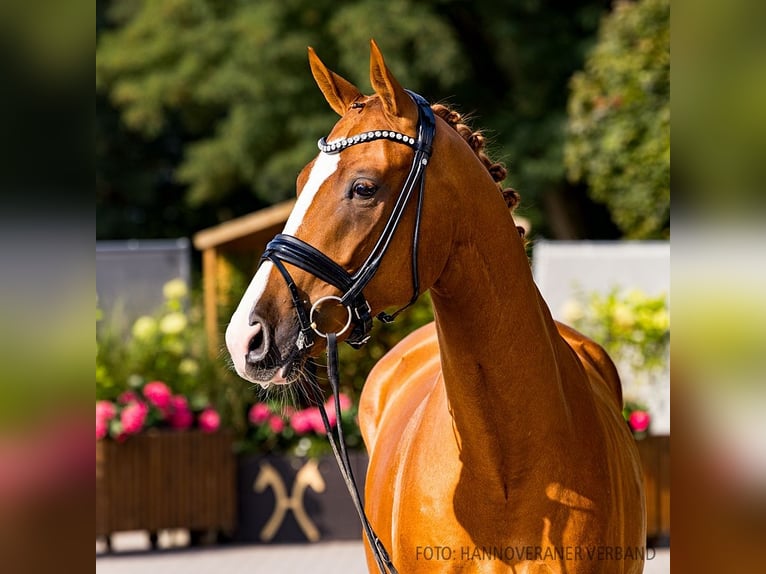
[226,153,340,379]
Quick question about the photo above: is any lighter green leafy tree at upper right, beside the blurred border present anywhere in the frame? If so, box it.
[565,0,670,239]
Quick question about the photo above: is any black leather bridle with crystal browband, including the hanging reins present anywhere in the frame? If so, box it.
[261,90,436,573]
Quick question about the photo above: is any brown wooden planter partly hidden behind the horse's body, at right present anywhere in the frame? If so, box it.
[636,435,670,545]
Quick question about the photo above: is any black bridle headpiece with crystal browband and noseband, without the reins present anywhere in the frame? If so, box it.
[261,90,436,349]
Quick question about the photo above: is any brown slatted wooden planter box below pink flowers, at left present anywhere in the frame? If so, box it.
[96,430,236,536]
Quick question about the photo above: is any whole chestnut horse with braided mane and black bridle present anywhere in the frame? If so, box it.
[226,41,646,574]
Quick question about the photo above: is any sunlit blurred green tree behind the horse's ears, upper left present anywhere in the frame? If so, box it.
[96,0,468,212]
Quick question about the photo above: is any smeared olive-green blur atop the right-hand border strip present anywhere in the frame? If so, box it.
[673,0,766,214]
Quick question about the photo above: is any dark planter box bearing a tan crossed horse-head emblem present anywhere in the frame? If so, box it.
[234,452,368,543]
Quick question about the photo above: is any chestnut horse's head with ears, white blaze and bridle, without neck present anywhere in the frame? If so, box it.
[226,41,464,386]
